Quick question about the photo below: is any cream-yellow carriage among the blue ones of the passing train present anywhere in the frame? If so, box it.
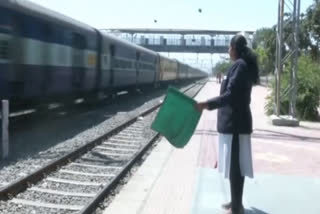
[159,55,178,83]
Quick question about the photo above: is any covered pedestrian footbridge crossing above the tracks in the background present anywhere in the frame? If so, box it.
[106,28,254,54]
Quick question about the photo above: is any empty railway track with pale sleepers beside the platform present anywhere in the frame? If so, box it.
[0,81,205,214]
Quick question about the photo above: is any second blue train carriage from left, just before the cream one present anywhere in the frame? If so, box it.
[100,32,157,91]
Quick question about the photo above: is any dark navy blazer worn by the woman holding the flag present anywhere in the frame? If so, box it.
[207,58,252,134]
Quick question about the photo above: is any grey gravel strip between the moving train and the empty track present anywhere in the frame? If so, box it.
[0,85,168,188]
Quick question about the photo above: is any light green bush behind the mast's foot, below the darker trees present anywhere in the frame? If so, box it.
[265,55,320,120]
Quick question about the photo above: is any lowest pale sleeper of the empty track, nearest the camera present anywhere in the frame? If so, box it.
[9,199,84,211]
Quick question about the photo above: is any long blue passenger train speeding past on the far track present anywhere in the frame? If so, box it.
[0,0,207,107]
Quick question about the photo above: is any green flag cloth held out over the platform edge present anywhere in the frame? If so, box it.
[151,87,201,148]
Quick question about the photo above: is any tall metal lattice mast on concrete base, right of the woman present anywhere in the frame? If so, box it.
[272,0,300,126]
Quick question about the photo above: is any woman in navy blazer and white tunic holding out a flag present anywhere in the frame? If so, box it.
[196,35,259,214]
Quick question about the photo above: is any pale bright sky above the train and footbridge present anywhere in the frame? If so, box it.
[27,0,313,72]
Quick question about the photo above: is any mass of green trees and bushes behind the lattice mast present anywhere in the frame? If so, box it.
[262,0,320,120]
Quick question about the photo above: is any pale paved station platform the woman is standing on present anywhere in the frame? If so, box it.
[104,81,320,214]
